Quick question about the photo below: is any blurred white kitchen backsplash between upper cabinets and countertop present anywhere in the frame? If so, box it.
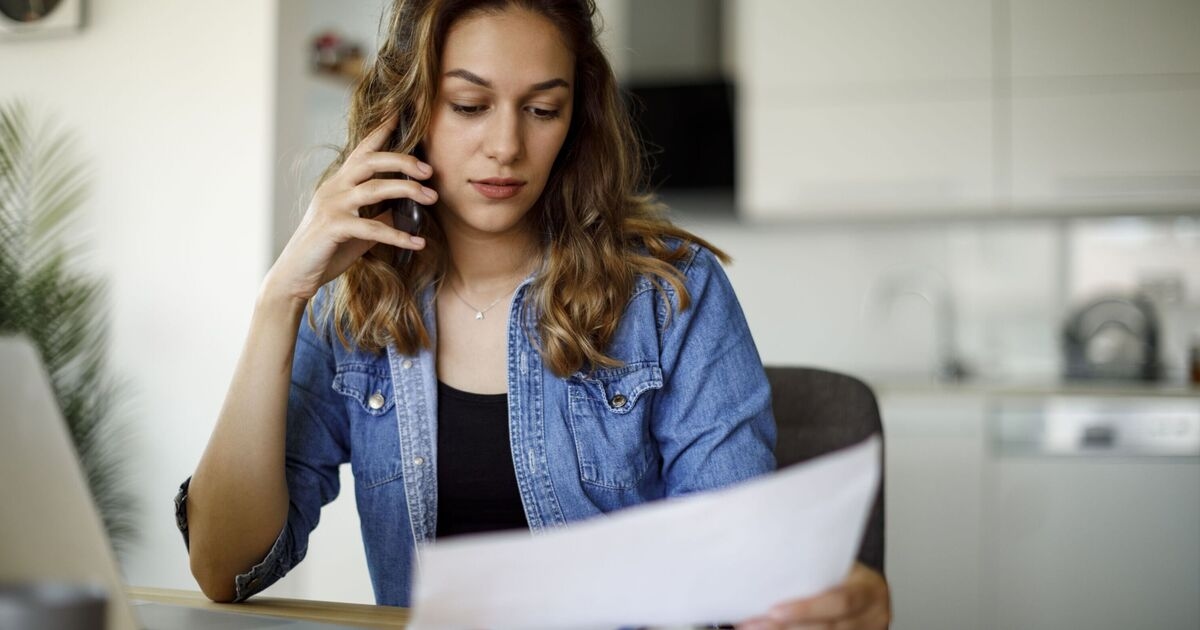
[676,211,1200,382]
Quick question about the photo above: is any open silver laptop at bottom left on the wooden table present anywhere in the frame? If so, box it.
[0,337,360,630]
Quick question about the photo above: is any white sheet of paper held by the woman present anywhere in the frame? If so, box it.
[409,437,880,629]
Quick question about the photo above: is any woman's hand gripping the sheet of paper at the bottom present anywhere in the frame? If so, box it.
[738,563,892,630]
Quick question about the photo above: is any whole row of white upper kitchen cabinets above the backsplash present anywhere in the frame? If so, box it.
[730,0,1200,220]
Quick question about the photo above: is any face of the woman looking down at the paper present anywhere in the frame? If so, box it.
[425,8,575,241]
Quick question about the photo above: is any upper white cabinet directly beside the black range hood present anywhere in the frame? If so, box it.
[731,0,994,218]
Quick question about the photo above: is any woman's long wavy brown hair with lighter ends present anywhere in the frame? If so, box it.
[320,0,728,377]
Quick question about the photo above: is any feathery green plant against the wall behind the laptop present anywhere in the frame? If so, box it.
[0,103,136,550]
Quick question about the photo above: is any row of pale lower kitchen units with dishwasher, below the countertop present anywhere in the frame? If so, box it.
[875,383,1200,630]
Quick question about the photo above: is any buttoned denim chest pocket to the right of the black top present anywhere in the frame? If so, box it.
[568,362,662,490]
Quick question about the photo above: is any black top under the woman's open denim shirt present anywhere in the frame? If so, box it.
[437,380,529,538]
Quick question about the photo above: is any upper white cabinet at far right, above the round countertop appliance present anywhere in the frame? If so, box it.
[1001,0,1200,214]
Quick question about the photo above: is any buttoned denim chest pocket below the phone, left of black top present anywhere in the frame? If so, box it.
[334,365,401,490]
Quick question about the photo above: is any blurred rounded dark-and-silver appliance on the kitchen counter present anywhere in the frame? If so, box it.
[1062,294,1162,380]
